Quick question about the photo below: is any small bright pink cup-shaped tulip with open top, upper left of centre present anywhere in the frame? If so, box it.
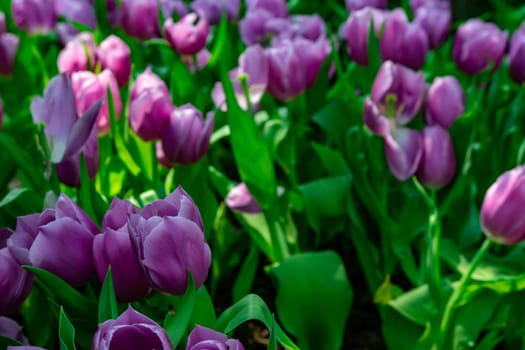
[164,13,210,55]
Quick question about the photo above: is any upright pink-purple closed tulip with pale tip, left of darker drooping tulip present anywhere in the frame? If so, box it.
[129,68,173,141]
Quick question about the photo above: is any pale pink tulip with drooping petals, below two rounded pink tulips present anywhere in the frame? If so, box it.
[71,69,122,135]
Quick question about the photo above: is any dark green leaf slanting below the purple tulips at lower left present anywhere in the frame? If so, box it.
[22,265,97,320]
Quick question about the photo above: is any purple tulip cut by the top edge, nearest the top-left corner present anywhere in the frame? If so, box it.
[11,0,57,34]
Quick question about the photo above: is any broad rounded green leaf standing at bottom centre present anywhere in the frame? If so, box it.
[271,251,353,349]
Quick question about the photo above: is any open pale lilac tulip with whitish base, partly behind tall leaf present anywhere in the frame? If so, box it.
[212,45,268,111]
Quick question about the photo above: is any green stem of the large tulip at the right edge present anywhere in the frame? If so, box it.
[439,238,492,348]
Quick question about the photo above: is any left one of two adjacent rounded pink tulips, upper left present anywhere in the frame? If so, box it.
[57,33,97,74]
